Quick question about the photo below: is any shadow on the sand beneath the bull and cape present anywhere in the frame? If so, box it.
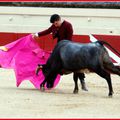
[0,87,109,99]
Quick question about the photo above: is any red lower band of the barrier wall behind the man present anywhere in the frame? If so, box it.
[0,32,120,57]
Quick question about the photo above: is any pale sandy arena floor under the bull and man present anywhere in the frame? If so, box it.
[0,69,120,118]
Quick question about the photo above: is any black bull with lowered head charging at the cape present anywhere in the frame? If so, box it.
[37,40,120,96]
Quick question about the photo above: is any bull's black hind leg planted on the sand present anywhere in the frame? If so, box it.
[96,68,113,96]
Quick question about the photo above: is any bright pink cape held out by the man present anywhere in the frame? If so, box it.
[0,34,60,89]
